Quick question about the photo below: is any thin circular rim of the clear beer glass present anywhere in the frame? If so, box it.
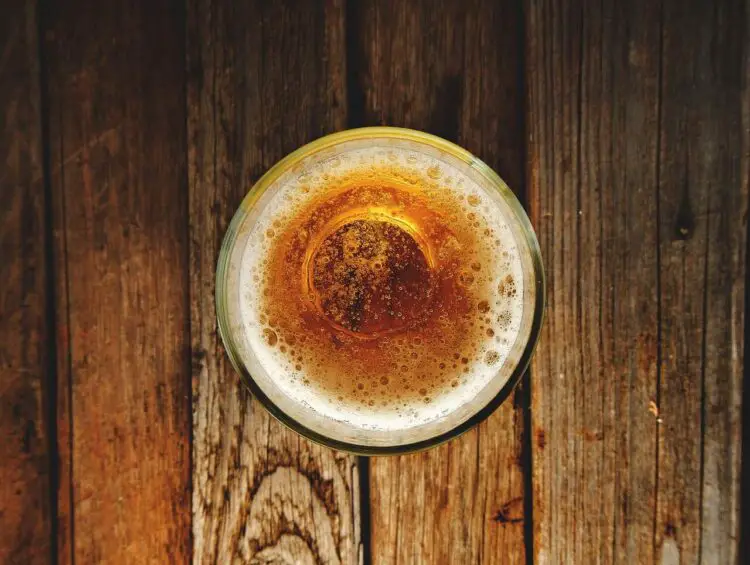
[215,126,546,456]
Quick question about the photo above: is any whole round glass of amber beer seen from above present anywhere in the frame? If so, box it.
[216,127,544,455]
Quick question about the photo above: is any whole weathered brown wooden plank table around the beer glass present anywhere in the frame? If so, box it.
[0,0,750,565]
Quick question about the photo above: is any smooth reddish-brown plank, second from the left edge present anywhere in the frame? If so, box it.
[43,0,191,563]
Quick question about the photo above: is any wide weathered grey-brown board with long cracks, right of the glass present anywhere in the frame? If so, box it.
[527,0,748,564]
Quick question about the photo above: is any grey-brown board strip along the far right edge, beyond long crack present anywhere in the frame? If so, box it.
[654,0,748,565]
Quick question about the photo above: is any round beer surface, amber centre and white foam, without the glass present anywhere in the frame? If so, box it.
[240,143,523,430]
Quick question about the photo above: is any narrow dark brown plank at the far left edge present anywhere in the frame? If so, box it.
[0,0,51,565]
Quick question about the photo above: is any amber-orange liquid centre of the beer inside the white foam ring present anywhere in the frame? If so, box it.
[260,167,515,409]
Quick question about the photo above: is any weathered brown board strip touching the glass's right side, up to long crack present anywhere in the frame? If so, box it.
[527,2,659,563]
